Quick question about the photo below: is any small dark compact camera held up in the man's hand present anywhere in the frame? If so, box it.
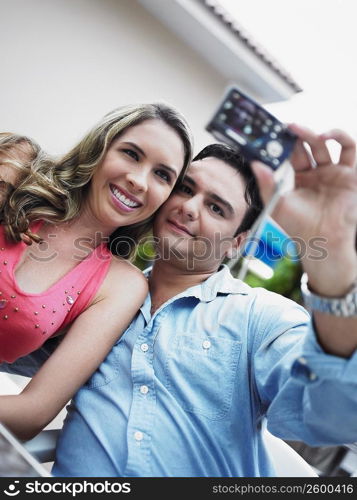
[206,86,296,170]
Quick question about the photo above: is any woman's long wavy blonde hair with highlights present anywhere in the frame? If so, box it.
[0,103,192,258]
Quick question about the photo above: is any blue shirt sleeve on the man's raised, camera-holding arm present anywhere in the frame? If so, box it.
[253,292,357,446]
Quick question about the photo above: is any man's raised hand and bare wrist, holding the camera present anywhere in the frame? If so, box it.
[252,125,357,356]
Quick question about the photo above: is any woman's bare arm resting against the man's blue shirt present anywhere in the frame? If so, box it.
[0,259,148,439]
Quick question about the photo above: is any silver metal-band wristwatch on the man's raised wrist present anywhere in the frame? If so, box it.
[301,273,357,318]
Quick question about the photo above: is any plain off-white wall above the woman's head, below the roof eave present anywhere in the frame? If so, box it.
[0,0,227,154]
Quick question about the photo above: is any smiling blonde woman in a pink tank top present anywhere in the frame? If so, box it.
[0,104,191,439]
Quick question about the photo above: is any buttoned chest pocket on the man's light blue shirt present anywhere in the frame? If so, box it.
[165,333,242,420]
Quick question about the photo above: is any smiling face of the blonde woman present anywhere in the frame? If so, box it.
[87,119,184,234]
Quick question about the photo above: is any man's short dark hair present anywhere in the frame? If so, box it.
[192,144,263,236]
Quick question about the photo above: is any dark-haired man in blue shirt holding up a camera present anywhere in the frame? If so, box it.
[2,127,357,477]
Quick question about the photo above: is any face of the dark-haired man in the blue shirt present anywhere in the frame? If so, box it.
[154,158,247,272]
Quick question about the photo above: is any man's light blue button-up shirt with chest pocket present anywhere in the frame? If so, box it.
[53,267,357,477]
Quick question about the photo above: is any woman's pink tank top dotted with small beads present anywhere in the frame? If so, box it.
[0,221,112,363]
